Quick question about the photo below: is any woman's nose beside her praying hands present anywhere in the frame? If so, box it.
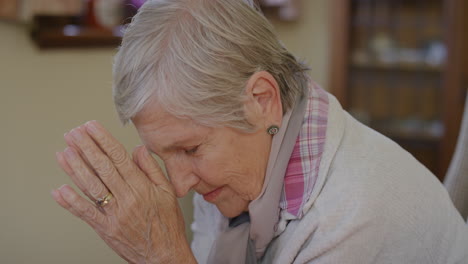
[165,157,200,198]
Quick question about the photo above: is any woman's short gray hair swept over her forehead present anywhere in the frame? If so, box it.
[113,0,307,131]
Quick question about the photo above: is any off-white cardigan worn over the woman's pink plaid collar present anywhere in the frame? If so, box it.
[192,95,468,264]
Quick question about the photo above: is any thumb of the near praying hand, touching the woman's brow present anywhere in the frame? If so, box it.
[133,146,170,185]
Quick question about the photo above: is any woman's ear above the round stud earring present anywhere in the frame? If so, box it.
[245,71,283,129]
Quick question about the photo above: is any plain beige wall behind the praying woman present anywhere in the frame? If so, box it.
[0,0,328,264]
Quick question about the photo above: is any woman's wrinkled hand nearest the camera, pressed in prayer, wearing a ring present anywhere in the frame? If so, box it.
[52,121,195,263]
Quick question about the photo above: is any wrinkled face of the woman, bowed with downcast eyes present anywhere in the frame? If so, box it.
[132,104,272,217]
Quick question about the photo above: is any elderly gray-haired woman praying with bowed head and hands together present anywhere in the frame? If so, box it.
[52,0,468,264]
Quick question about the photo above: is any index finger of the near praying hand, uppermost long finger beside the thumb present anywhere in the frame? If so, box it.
[84,121,146,186]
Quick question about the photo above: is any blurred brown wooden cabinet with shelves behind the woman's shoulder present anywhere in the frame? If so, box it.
[330,0,468,180]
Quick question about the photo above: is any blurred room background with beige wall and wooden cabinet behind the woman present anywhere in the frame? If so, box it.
[0,0,468,263]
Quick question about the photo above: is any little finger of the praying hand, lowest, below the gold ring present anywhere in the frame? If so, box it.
[52,185,107,229]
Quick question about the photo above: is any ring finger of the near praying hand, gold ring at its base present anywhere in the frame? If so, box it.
[59,147,109,204]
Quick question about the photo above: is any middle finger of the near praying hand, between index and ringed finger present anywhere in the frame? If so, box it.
[67,128,128,197]
